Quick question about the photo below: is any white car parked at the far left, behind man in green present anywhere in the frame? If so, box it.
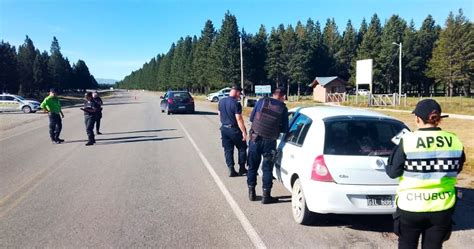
[0,93,41,113]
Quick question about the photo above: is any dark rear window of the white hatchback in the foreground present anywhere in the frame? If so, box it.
[324,119,405,156]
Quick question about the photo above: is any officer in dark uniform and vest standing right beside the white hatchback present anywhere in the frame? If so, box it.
[247,88,288,204]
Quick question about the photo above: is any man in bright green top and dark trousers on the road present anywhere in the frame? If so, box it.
[41,88,64,144]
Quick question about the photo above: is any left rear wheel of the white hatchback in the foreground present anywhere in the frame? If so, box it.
[291,179,312,225]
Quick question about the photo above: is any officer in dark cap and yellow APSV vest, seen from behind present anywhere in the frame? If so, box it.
[386,99,465,249]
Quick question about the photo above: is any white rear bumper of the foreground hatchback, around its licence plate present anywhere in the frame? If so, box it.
[302,179,397,214]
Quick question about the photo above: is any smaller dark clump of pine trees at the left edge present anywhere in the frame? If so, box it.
[0,36,98,97]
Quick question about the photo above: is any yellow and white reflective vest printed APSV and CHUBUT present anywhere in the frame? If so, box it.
[397,130,463,212]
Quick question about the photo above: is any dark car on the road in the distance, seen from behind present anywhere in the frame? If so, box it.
[160,91,194,115]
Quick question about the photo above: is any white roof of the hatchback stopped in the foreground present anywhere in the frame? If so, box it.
[292,106,396,120]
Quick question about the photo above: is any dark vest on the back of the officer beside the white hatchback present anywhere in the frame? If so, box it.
[251,97,284,140]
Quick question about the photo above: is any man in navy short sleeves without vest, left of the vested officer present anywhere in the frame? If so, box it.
[219,85,247,177]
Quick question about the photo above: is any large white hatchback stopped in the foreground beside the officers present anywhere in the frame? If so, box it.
[273,106,407,224]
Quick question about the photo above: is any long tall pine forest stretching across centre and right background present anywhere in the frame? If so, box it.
[118,10,474,96]
